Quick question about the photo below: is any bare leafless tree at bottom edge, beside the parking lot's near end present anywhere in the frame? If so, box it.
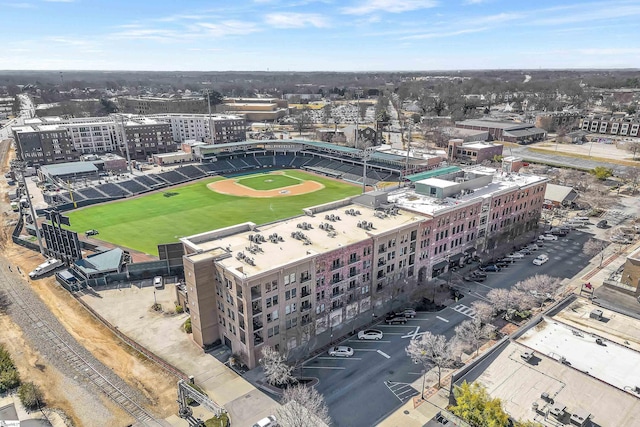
[276,385,331,427]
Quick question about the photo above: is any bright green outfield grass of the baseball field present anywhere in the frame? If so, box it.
[66,170,360,255]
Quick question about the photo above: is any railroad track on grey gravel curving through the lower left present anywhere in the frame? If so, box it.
[0,267,162,427]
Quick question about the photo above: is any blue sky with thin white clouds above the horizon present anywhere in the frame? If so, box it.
[0,0,640,71]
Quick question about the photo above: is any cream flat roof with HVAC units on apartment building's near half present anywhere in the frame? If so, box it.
[181,204,425,276]
